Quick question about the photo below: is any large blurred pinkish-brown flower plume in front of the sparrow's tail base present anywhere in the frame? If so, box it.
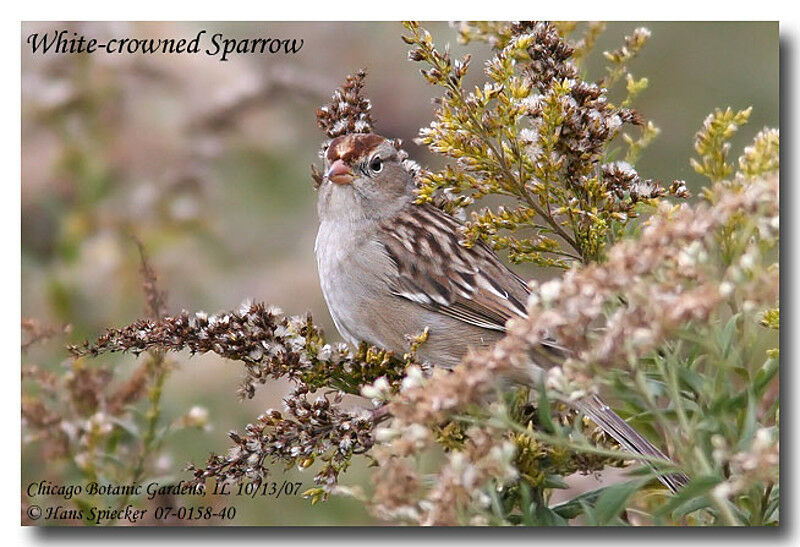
[510,175,779,384]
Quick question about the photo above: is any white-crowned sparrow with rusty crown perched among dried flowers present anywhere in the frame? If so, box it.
[315,133,687,491]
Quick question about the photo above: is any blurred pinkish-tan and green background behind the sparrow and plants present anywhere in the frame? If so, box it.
[22,22,779,525]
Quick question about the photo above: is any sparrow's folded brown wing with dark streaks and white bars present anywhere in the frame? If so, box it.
[382,205,529,331]
